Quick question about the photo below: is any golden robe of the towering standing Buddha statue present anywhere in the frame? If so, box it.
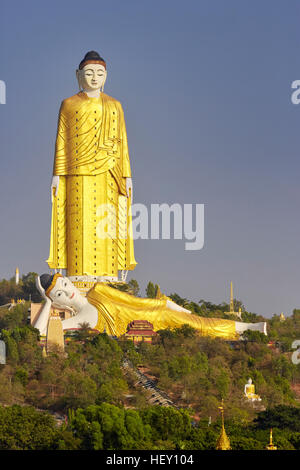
[47,92,137,277]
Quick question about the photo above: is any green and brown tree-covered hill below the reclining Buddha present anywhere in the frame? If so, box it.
[0,275,300,450]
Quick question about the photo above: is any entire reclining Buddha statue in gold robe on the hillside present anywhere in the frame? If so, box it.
[34,273,264,340]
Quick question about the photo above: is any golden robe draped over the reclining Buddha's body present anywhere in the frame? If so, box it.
[87,283,239,340]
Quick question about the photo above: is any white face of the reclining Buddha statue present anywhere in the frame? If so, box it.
[49,277,82,309]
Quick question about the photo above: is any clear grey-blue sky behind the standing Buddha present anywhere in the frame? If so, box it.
[0,0,300,316]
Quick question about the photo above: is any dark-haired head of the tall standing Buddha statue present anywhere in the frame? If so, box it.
[76,51,107,91]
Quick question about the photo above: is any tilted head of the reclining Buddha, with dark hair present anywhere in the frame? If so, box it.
[36,273,84,311]
